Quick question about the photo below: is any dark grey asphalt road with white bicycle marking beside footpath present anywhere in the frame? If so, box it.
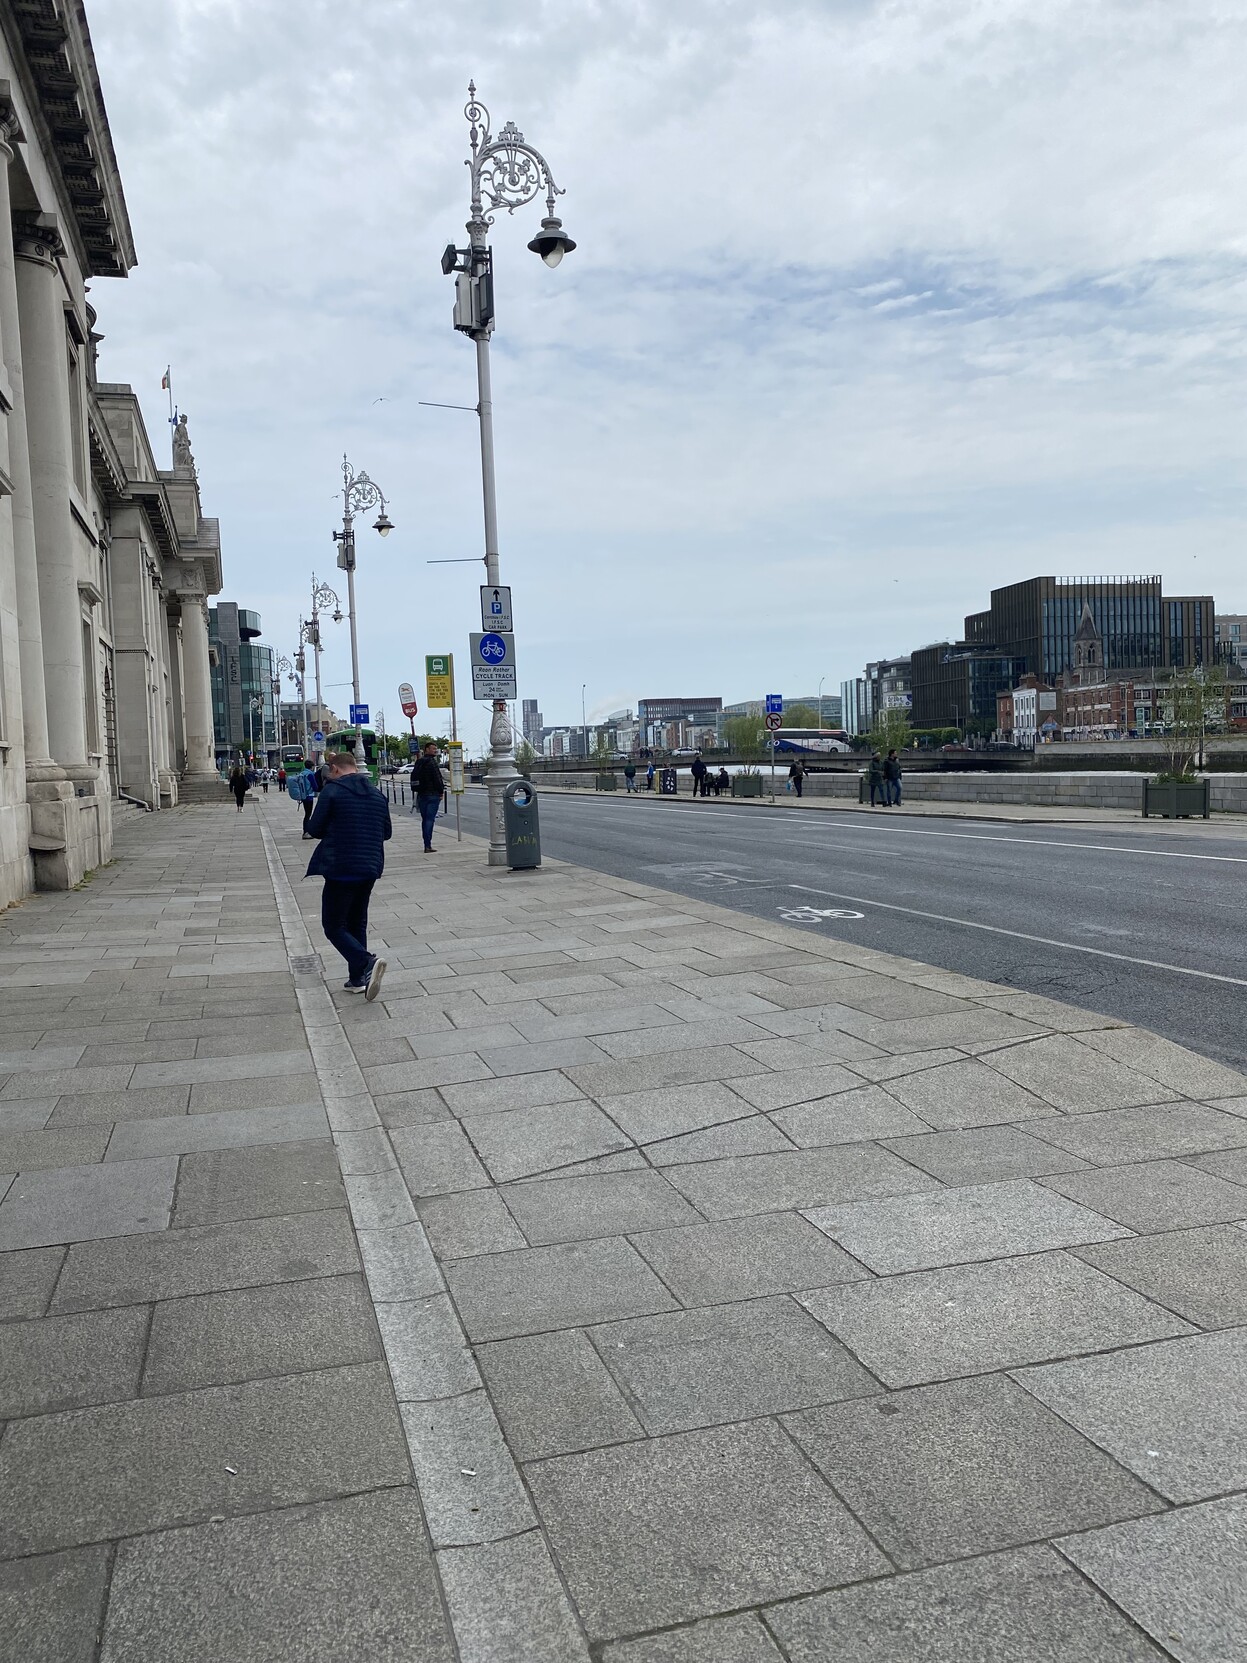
[455,788,1247,1071]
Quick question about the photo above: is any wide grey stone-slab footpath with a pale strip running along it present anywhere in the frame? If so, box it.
[0,795,1247,1663]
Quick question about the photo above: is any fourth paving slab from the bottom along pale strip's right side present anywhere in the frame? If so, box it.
[446,1237,675,1340]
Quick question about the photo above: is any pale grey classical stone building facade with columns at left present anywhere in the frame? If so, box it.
[0,0,221,906]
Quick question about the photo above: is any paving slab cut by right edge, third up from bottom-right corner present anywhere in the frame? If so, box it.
[1077,1224,1247,1329]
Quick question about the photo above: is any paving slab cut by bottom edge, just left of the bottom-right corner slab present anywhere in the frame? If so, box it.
[766,1547,1170,1663]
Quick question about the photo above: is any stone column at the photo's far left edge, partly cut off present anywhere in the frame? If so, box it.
[0,117,57,783]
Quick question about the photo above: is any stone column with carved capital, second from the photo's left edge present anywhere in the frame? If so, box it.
[17,215,88,785]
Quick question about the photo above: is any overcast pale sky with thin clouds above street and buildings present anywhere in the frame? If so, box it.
[86,0,1247,742]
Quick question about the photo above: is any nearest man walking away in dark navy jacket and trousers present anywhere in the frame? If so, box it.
[308,750,392,1003]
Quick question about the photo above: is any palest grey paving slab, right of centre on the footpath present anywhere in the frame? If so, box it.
[805,1177,1137,1276]
